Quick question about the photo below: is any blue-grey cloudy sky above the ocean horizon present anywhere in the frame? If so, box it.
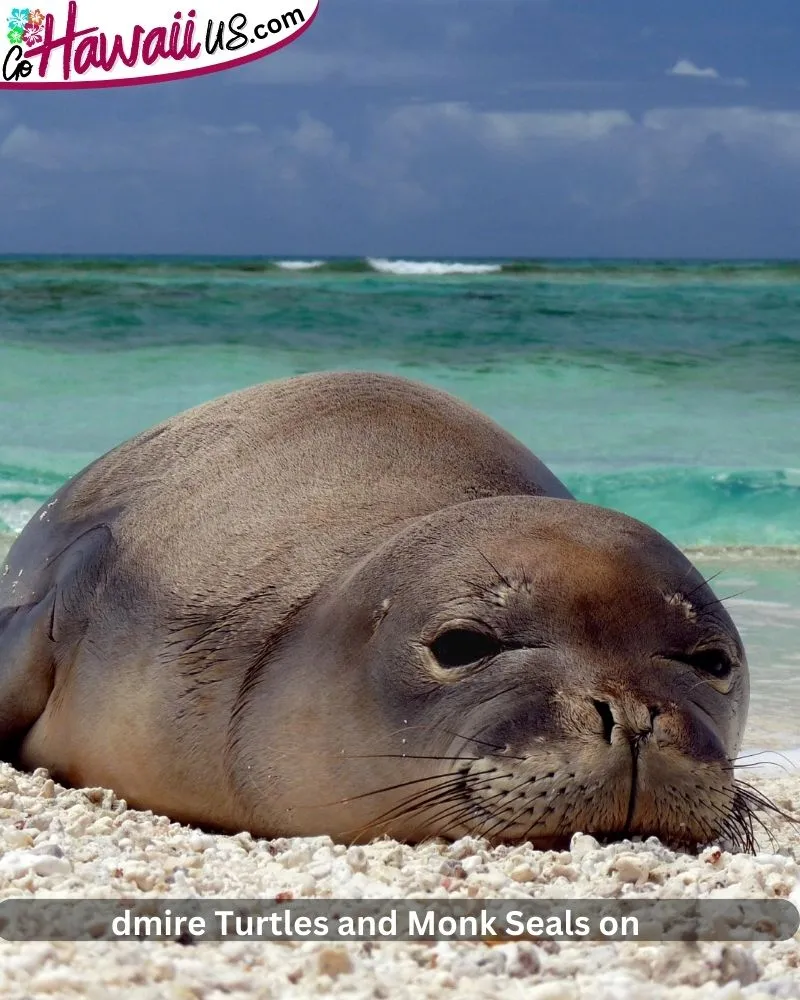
[0,0,800,258]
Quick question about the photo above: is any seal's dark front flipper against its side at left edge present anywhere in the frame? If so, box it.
[0,524,113,758]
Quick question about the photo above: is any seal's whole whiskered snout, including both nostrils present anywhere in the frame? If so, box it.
[334,696,793,853]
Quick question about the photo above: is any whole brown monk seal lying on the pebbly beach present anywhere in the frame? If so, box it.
[0,373,752,846]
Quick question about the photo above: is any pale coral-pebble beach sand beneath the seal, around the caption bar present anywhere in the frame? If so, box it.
[0,765,800,1000]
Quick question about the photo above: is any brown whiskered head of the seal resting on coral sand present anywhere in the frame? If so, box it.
[235,497,749,847]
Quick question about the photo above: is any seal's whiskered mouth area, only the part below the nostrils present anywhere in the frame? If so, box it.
[444,735,781,853]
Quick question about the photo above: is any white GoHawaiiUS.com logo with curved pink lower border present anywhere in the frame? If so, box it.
[0,0,319,90]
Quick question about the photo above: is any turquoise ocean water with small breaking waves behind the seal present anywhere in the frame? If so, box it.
[0,258,800,747]
